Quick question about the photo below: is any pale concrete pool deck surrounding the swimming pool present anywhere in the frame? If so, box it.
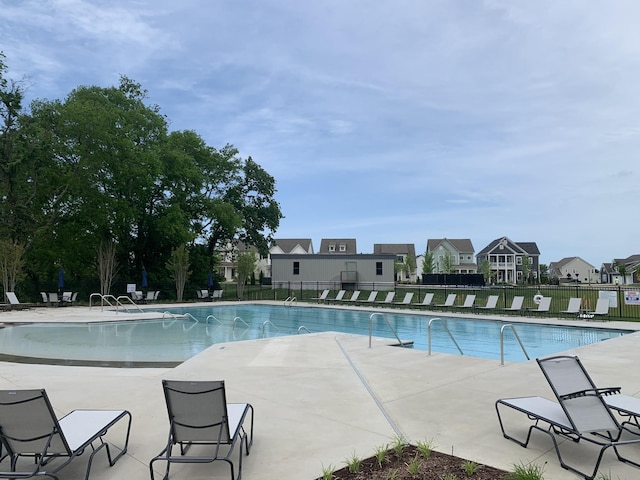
[0,302,640,480]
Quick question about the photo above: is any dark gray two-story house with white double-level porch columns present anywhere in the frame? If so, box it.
[476,237,540,283]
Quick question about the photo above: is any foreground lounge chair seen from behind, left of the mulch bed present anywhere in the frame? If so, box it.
[149,380,253,480]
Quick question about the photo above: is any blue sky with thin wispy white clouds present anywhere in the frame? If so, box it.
[0,0,640,268]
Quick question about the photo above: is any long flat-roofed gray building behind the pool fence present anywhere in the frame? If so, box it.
[271,253,396,290]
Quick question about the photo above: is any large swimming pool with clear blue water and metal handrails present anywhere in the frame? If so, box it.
[0,304,631,367]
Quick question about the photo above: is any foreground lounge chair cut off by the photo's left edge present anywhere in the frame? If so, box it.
[0,389,131,480]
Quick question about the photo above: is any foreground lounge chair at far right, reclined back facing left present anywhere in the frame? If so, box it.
[496,356,640,480]
